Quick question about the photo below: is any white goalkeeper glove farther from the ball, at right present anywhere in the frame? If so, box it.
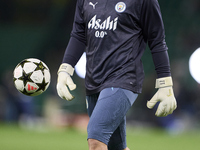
[147,77,177,117]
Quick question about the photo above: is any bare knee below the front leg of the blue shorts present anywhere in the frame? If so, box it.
[88,139,108,150]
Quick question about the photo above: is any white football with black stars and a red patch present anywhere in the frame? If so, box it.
[13,58,51,96]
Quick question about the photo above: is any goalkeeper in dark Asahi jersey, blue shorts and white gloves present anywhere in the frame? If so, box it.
[57,0,176,150]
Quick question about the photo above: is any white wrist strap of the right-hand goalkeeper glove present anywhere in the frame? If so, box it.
[155,77,173,88]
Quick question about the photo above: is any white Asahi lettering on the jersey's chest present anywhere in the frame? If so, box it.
[88,15,118,31]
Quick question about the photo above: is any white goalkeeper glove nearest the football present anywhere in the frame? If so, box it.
[56,63,76,101]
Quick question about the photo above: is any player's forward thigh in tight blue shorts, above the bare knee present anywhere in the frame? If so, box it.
[88,88,137,144]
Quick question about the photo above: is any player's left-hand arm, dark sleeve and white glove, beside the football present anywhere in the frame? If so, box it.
[56,0,86,100]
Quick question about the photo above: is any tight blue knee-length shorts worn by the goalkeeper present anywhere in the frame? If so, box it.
[86,88,138,150]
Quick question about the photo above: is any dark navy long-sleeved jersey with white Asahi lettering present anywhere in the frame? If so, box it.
[63,0,171,95]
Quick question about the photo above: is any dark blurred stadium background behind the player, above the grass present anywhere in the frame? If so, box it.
[0,0,200,137]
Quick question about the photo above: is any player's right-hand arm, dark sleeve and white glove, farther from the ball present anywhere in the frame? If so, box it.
[140,0,177,117]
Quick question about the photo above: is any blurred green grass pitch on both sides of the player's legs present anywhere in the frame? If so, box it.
[0,125,200,150]
